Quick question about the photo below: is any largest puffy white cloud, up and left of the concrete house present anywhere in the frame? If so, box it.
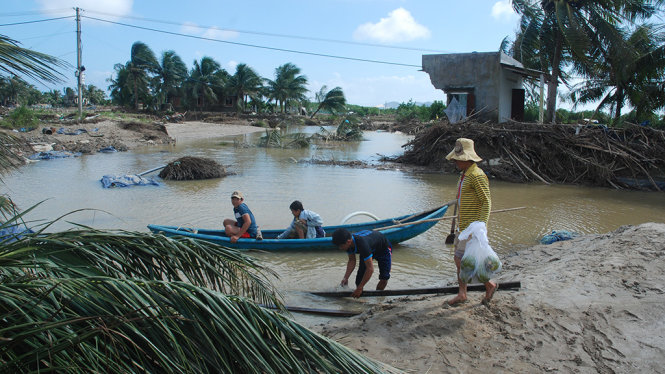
[353,8,430,43]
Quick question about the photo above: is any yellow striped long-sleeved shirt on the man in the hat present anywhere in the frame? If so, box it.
[457,163,492,231]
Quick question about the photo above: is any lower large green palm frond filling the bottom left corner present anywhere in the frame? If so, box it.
[0,277,392,373]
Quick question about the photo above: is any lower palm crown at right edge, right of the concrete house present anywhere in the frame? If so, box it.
[571,24,665,121]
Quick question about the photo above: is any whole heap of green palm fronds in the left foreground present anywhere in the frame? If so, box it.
[0,228,392,373]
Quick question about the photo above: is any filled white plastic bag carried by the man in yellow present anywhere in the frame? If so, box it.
[459,221,502,283]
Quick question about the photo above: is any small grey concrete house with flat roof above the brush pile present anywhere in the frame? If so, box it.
[422,52,544,123]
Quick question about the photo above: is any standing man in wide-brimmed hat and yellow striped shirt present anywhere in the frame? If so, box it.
[446,138,497,306]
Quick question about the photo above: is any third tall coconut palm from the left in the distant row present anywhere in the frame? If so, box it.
[189,57,228,109]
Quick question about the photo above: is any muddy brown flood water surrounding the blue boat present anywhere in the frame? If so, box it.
[3,128,665,322]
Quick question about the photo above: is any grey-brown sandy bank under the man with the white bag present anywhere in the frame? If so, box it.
[314,223,665,373]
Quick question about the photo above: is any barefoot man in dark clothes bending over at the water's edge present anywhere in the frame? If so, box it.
[332,228,392,298]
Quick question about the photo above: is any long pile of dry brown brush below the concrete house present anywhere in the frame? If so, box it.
[395,121,665,191]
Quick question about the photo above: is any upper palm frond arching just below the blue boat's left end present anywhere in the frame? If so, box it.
[0,228,281,305]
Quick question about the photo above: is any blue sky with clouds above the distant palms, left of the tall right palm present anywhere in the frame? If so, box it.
[0,0,518,106]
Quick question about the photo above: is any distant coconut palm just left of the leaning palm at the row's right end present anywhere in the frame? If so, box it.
[267,62,307,113]
